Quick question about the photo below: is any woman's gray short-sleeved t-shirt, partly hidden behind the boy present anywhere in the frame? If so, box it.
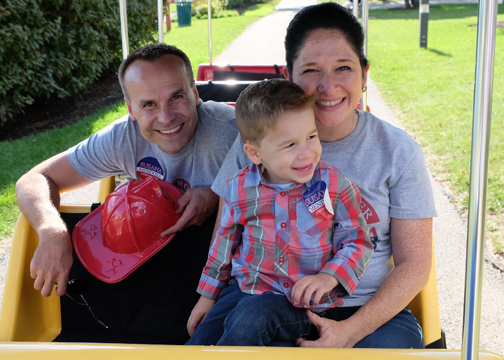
[212,111,437,306]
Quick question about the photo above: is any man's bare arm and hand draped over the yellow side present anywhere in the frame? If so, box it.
[16,152,92,296]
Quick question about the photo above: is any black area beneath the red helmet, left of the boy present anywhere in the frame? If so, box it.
[54,214,215,344]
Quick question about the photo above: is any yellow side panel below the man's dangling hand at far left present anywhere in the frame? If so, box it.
[0,215,61,341]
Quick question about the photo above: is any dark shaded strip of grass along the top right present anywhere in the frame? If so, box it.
[369,4,504,20]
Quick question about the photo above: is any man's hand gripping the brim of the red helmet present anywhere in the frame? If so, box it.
[161,186,219,237]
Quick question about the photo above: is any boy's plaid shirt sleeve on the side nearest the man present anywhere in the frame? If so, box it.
[196,181,243,299]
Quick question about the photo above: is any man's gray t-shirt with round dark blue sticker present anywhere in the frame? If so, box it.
[68,99,238,191]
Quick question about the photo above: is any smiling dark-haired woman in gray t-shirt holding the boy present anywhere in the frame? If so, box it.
[212,3,436,348]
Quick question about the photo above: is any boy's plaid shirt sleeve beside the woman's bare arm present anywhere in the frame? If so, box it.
[321,174,374,295]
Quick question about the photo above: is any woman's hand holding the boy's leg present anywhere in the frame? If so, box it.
[296,310,358,348]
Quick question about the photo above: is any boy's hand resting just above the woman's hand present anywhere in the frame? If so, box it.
[291,273,339,307]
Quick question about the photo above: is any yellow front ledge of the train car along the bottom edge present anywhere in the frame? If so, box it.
[0,343,504,360]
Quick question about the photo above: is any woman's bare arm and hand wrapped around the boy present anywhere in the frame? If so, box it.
[297,218,432,348]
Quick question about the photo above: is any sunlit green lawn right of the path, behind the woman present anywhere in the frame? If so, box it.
[368,4,504,250]
